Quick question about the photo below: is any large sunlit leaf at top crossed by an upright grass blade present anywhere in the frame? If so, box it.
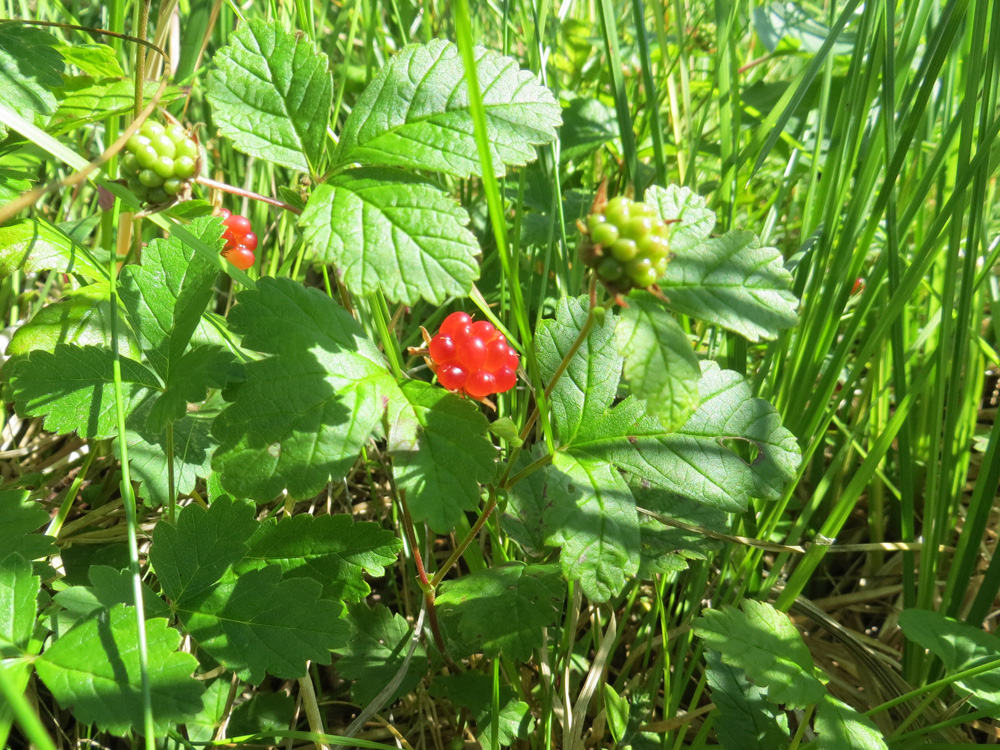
[334,39,560,177]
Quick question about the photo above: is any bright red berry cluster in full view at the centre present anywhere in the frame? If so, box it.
[427,312,519,399]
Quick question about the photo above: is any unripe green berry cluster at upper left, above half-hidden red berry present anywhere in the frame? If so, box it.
[122,120,198,204]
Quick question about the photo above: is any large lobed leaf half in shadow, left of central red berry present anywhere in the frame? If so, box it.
[212,278,398,502]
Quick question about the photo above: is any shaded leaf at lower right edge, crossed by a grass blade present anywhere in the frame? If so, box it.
[899,609,1000,708]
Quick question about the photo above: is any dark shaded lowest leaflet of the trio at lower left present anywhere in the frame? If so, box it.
[180,568,348,684]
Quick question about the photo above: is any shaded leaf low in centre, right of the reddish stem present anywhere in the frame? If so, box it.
[435,562,566,661]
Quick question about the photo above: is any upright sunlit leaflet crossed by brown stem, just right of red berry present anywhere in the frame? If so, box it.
[535,297,622,445]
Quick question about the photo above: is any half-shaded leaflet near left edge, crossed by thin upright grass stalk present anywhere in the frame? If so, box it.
[11,344,160,438]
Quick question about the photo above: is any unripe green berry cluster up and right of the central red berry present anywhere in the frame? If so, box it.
[580,196,670,294]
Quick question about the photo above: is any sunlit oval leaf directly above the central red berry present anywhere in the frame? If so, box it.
[300,168,479,305]
